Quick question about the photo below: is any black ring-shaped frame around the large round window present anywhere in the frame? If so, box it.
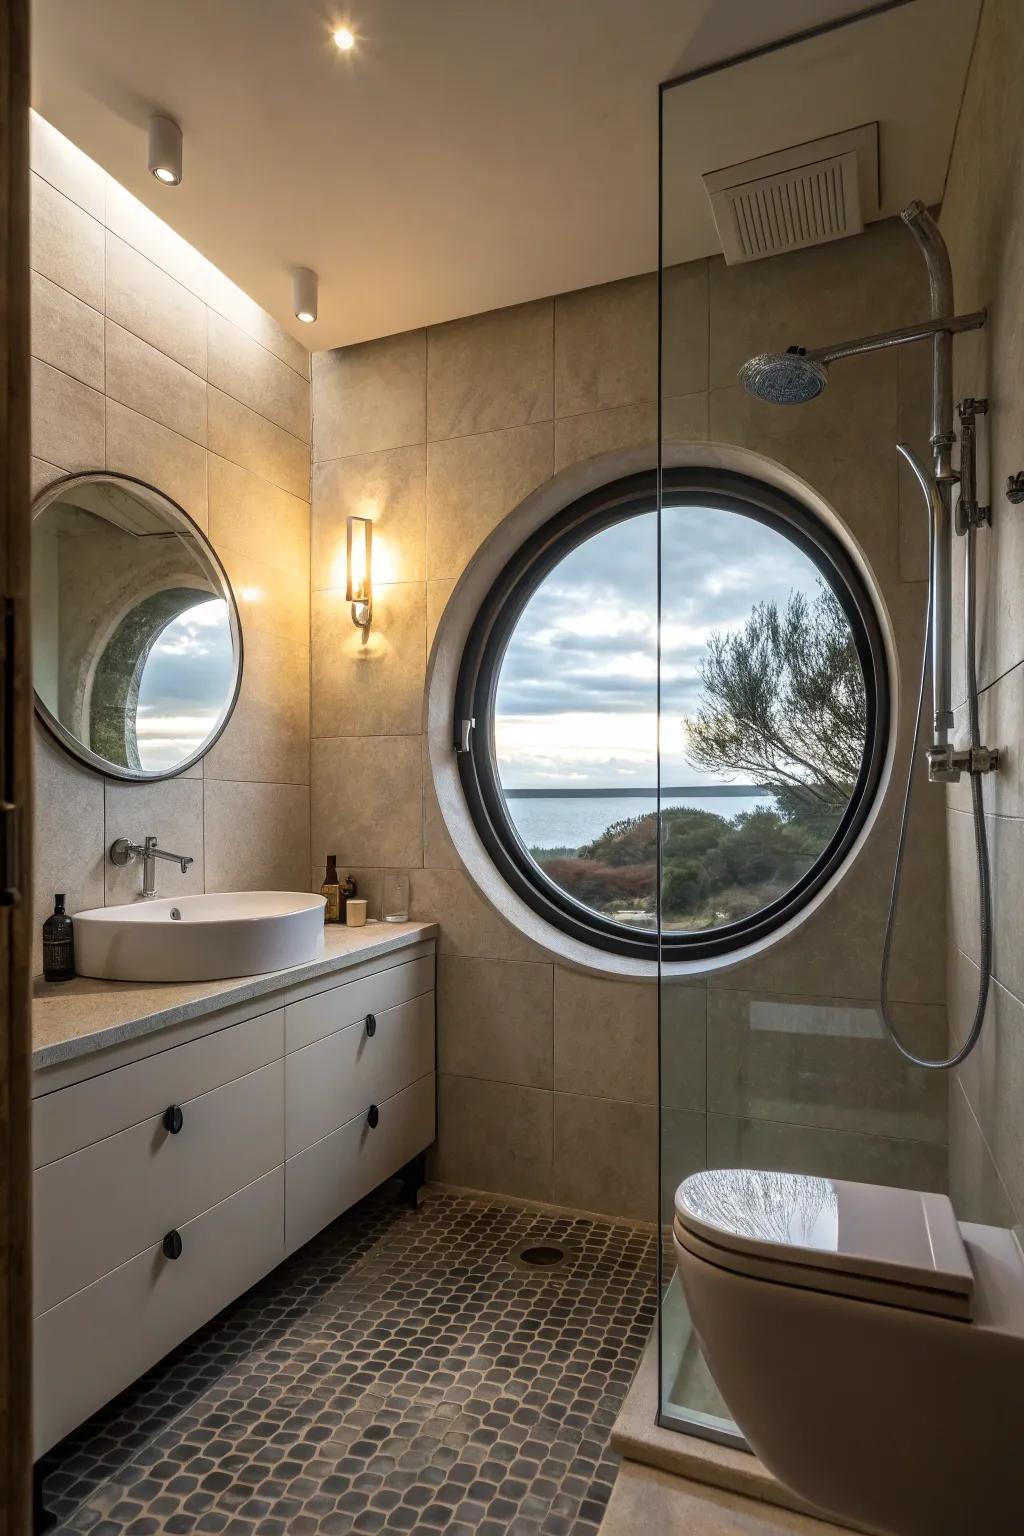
[453,467,890,960]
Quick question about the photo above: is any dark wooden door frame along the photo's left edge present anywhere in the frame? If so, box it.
[0,0,32,1536]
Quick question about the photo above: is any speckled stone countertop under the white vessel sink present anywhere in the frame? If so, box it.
[32,922,438,1069]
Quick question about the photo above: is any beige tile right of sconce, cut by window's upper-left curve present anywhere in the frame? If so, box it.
[427,422,554,581]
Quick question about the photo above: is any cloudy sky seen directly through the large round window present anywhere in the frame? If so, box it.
[496,507,817,790]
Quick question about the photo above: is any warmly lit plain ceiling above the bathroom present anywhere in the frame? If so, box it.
[32,0,979,349]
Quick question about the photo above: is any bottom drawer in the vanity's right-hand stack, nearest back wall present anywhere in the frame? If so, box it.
[284,1072,436,1253]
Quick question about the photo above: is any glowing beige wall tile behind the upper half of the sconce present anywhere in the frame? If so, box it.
[312,444,427,587]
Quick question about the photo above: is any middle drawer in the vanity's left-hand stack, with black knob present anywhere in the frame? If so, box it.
[32,1060,284,1326]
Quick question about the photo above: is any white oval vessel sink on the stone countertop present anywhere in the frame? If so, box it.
[74,891,324,982]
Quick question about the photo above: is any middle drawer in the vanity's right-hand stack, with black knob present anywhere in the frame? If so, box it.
[284,992,434,1157]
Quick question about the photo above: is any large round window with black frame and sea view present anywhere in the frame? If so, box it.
[454,468,889,958]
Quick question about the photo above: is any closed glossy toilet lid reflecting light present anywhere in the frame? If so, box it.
[676,1169,973,1316]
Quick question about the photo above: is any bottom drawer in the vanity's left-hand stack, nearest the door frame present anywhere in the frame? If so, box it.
[34,1167,284,1456]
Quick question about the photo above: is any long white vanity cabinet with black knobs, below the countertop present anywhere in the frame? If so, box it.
[34,940,434,1456]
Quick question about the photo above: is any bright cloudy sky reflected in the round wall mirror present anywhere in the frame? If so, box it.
[135,598,233,773]
